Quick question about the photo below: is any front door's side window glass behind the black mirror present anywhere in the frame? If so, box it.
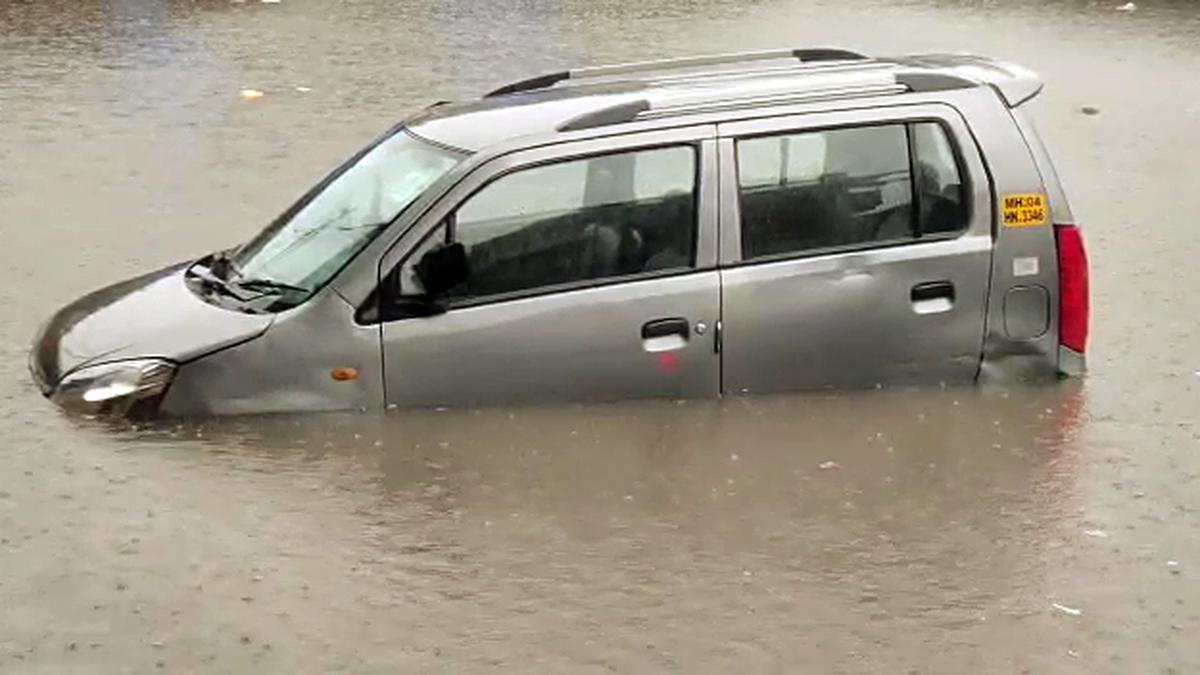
[401,147,696,300]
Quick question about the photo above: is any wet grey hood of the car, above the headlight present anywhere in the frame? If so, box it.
[30,264,274,390]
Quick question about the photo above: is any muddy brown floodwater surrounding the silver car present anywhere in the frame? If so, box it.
[0,0,1200,674]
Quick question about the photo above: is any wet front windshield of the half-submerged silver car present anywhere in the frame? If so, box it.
[230,130,464,294]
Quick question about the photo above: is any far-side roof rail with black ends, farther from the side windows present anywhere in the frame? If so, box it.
[484,47,869,98]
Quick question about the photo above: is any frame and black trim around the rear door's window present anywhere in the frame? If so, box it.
[718,102,996,269]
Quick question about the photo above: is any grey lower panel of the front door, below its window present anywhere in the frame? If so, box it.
[383,271,720,406]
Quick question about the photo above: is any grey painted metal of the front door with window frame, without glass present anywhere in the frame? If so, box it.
[379,126,720,406]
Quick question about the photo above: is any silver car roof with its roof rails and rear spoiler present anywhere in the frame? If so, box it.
[407,48,1042,151]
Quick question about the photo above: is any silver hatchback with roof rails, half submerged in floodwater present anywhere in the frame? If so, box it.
[30,49,1088,416]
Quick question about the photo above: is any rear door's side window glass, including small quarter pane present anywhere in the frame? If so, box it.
[738,123,967,259]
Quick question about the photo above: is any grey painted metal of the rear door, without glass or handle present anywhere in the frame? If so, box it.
[719,104,992,393]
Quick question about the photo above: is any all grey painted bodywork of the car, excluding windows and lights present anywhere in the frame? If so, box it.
[31,49,1086,414]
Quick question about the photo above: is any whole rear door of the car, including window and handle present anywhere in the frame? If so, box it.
[719,104,992,393]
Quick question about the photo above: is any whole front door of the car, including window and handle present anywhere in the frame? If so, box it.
[380,126,720,407]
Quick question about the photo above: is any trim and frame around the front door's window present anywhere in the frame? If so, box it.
[376,139,719,323]
